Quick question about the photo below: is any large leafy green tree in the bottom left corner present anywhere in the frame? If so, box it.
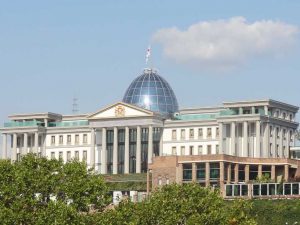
[0,154,110,224]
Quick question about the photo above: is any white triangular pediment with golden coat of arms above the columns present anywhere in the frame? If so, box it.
[88,102,153,119]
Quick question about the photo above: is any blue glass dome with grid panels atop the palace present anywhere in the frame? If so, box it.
[123,69,178,115]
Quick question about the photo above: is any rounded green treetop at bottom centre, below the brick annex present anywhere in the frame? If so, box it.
[89,184,256,225]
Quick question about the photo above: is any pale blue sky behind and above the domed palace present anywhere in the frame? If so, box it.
[0,0,300,122]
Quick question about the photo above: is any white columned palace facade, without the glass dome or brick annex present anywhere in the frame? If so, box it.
[1,100,298,174]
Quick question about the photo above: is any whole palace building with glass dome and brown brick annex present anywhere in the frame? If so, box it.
[1,69,300,192]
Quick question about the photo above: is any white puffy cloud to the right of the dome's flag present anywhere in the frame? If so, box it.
[152,17,299,69]
